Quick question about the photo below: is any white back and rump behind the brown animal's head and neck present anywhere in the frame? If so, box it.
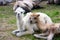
[33,12,53,24]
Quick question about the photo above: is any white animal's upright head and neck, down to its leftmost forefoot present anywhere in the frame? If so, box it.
[12,7,25,34]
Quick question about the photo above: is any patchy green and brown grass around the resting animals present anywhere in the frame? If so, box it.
[0,2,60,40]
